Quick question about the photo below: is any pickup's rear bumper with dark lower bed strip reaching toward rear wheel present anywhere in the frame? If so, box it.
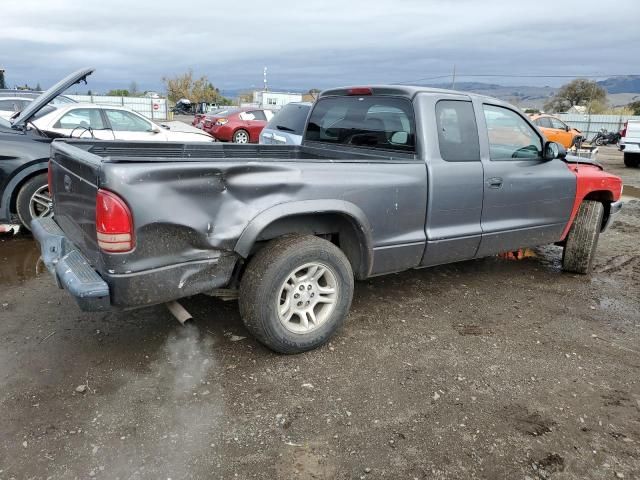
[31,218,238,311]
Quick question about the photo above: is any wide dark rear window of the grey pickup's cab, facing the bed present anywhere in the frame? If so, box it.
[305,96,415,152]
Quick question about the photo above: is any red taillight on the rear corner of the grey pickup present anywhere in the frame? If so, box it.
[96,189,135,253]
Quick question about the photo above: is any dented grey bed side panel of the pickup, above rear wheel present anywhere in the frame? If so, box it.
[54,142,427,275]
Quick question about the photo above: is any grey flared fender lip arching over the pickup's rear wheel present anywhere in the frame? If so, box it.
[234,200,373,279]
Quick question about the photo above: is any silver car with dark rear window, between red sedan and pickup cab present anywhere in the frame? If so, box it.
[260,102,312,145]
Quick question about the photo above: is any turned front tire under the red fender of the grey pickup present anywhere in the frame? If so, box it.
[562,200,604,274]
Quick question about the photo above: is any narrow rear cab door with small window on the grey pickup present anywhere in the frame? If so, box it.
[418,94,483,266]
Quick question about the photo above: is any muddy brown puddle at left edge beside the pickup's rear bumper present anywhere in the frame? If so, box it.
[0,235,46,285]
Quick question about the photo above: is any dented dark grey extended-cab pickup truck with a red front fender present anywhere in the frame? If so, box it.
[32,86,622,353]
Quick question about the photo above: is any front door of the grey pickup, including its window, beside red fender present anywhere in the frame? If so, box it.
[476,101,576,257]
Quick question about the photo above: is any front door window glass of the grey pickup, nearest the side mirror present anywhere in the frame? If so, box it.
[483,105,542,161]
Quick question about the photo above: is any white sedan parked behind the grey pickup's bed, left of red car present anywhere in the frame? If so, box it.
[32,103,214,142]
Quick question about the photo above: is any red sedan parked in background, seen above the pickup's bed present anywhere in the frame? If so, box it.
[204,109,273,143]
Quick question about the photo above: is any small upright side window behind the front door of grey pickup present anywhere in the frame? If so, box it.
[436,100,480,162]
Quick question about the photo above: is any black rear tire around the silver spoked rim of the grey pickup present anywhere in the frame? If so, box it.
[239,235,354,354]
